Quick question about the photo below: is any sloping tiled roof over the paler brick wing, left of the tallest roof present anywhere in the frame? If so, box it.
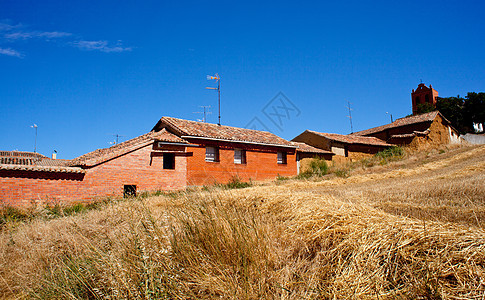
[69,130,187,166]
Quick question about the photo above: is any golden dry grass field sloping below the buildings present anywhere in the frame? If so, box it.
[0,147,485,299]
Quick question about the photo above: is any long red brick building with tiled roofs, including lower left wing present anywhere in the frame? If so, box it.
[0,117,297,206]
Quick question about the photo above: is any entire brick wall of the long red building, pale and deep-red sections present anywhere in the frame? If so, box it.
[0,143,297,206]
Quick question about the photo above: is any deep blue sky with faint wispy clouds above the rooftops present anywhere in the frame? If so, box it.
[0,0,485,158]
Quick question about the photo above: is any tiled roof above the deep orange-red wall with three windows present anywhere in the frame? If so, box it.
[153,117,294,147]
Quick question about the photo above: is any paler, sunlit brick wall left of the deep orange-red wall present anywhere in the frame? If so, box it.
[0,145,187,206]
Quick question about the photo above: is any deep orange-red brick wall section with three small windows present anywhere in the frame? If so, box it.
[187,144,297,185]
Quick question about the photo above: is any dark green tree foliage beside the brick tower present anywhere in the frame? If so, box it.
[436,93,485,133]
